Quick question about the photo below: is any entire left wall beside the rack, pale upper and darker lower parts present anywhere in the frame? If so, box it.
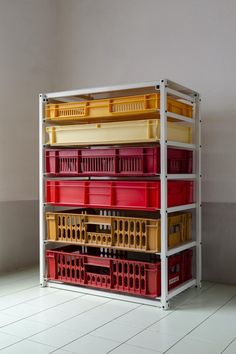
[0,0,57,273]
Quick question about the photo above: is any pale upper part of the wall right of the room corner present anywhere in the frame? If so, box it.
[56,0,236,202]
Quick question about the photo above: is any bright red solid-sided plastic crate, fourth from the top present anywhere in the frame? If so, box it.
[46,179,194,211]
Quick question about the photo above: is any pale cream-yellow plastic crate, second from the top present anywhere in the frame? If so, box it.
[46,119,192,146]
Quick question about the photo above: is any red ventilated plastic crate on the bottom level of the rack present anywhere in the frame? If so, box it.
[46,246,191,298]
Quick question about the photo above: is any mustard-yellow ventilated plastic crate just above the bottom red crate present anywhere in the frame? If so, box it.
[46,212,192,252]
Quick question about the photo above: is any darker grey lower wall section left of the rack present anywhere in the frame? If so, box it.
[0,200,39,273]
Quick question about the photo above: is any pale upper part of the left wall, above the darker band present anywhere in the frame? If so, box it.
[0,0,57,201]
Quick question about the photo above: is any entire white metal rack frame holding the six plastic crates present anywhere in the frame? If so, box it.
[39,79,202,309]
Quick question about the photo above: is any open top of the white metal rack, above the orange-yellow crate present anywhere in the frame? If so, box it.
[40,79,198,101]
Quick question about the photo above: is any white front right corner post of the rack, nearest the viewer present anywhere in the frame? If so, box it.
[160,80,168,309]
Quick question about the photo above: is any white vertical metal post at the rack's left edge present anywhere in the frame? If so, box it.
[39,94,46,286]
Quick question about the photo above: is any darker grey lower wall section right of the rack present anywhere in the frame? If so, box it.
[202,203,236,285]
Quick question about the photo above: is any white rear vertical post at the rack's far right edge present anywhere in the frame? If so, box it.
[195,95,202,287]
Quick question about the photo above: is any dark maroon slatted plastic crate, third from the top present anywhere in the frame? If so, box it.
[45,147,193,177]
